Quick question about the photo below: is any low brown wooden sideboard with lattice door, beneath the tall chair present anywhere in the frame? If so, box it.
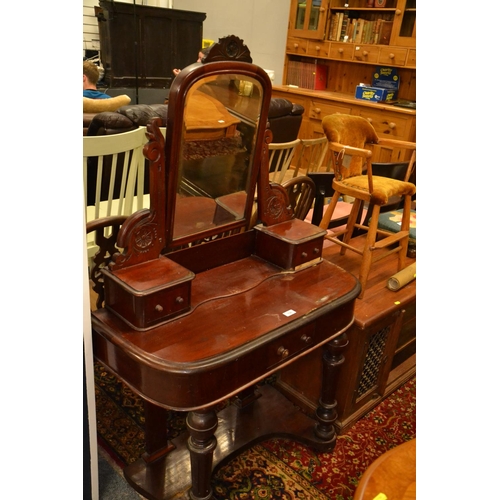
[277,237,416,433]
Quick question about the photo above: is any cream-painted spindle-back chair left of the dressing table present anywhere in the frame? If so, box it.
[83,127,149,259]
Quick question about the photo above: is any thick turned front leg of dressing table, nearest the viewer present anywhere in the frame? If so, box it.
[186,409,218,500]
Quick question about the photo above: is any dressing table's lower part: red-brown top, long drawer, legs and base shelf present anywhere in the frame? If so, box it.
[92,255,359,499]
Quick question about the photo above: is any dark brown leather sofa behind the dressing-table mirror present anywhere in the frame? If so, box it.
[83,98,304,143]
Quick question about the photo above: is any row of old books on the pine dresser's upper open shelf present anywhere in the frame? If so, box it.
[328,12,393,45]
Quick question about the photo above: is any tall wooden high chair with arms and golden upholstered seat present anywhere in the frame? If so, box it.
[320,114,416,298]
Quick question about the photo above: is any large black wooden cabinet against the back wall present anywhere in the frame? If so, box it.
[95,0,206,88]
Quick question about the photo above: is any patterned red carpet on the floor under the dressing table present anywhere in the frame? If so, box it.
[95,363,416,500]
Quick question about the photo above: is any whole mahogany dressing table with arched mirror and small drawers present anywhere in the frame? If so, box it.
[92,36,359,500]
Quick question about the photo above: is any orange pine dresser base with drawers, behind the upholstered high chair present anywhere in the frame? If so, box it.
[273,85,417,163]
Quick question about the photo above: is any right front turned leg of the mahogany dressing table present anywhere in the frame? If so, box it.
[314,333,349,446]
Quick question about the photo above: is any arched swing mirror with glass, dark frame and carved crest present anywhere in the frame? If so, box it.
[159,37,271,253]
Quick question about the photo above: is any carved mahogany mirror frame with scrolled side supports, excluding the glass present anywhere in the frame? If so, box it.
[109,35,293,271]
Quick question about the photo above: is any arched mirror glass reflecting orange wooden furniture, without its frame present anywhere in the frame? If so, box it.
[173,74,263,240]
